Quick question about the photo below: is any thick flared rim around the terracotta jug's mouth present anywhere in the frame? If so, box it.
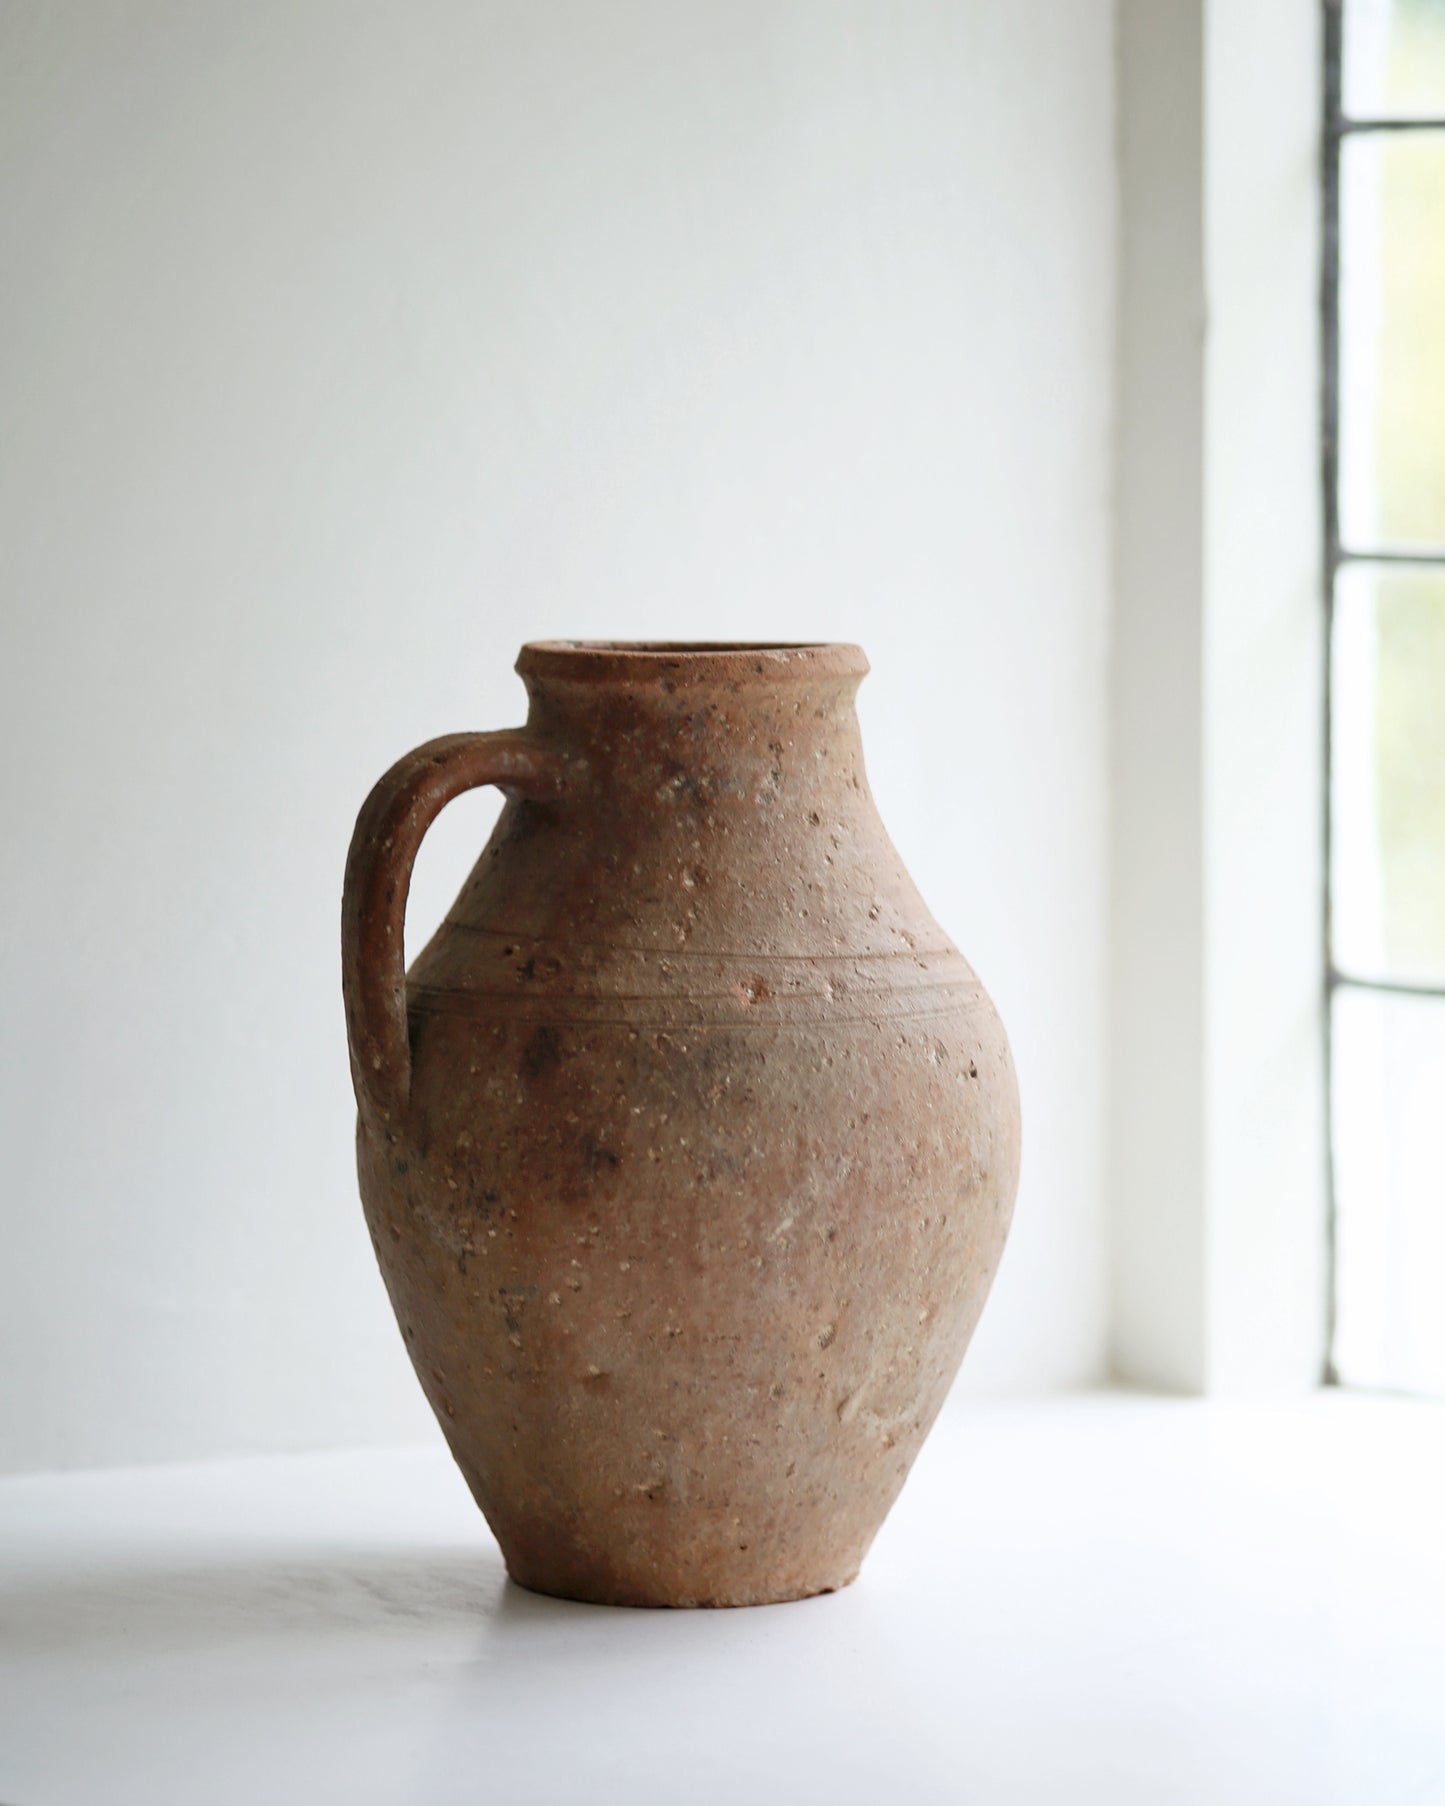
[517,639,869,683]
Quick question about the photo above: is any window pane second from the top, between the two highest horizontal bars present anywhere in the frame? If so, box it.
[1340,128,1445,551]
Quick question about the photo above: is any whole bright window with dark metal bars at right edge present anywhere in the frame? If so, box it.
[1322,0,1445,1394]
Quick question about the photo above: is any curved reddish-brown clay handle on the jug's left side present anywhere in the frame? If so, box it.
[341,728,564,1127]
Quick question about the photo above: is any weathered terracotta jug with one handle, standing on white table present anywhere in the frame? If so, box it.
[343,643,1019,1606]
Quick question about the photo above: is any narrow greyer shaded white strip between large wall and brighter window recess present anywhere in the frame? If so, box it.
[1109,0,1207,1391]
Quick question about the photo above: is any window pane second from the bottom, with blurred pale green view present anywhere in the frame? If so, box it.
[1331,565,1445,982]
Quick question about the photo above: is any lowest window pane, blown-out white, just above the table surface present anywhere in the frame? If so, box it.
[1333,988,1445,1394]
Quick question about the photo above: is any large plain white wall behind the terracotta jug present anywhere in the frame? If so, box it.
[0,0,1114,1468]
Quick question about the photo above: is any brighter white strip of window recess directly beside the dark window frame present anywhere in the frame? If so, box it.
[1203,0,1328,1392]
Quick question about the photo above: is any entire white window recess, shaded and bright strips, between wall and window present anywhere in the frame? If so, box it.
[1109,0,1326,1392]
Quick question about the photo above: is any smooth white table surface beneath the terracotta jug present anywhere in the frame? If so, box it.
[0,1394,1445,1806]
